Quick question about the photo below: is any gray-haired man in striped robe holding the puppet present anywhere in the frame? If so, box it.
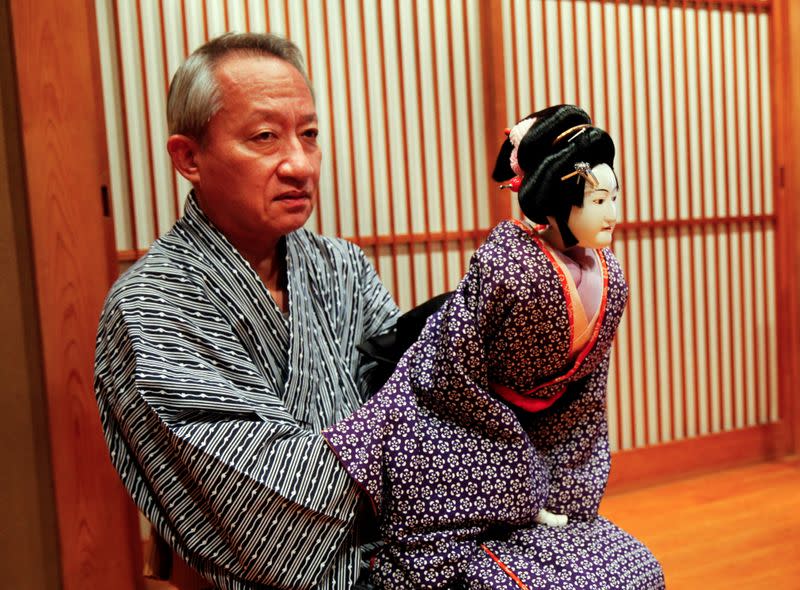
[95,34,397,590]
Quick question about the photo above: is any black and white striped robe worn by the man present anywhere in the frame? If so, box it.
[95,196,397,590]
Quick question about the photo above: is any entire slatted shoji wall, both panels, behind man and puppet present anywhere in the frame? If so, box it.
[96,0,779,456]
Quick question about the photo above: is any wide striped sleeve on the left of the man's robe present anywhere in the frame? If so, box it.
[95,308,357,589]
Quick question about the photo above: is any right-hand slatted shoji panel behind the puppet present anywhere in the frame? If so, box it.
[503,0,778,449]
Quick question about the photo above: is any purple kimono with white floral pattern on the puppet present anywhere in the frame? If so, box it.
[323,221,664,590]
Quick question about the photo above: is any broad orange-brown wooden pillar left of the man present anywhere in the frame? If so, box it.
[6,0,143,590]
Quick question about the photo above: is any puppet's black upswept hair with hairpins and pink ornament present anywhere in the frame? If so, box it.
[492,105,614,248]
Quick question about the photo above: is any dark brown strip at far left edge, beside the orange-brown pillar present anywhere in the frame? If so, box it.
[0,0,60,590]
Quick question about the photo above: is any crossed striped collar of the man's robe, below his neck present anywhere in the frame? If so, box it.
[178,193,361,430]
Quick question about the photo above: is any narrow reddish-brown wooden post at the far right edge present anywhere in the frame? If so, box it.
[770,0,800,454]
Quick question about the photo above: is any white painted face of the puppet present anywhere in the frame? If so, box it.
[567,164,619,249]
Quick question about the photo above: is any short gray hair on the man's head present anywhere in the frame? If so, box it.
[167,33,313,141]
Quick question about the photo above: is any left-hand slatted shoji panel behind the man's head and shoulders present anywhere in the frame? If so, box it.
[96,0,489,309]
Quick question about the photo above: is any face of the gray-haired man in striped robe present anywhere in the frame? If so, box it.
[192,55,322,249]
